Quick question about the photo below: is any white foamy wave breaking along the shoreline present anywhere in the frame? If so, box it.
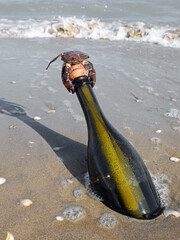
[0,17,180,48]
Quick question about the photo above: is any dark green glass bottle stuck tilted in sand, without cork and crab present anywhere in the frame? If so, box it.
[76,84,163,219]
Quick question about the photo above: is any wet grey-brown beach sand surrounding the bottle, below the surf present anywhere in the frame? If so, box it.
[0,39,180,240]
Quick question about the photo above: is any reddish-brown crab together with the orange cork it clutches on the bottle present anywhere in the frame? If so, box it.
[46,51,96,93]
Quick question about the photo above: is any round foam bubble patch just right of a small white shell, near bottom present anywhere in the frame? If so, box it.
[62,206,85,221]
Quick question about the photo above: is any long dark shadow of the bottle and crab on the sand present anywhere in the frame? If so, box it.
[0,99,88,184]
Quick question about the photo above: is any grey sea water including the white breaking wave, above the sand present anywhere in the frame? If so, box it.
[0,0,180,48]
